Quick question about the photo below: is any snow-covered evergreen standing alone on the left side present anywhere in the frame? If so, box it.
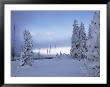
[20,30,33,66]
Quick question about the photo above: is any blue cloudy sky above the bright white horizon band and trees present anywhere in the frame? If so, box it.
[11,11,99,50]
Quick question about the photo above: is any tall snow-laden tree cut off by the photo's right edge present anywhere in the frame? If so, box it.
[86,12,100,76]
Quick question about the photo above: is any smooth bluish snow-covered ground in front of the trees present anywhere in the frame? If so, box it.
[11,55,88,77]
